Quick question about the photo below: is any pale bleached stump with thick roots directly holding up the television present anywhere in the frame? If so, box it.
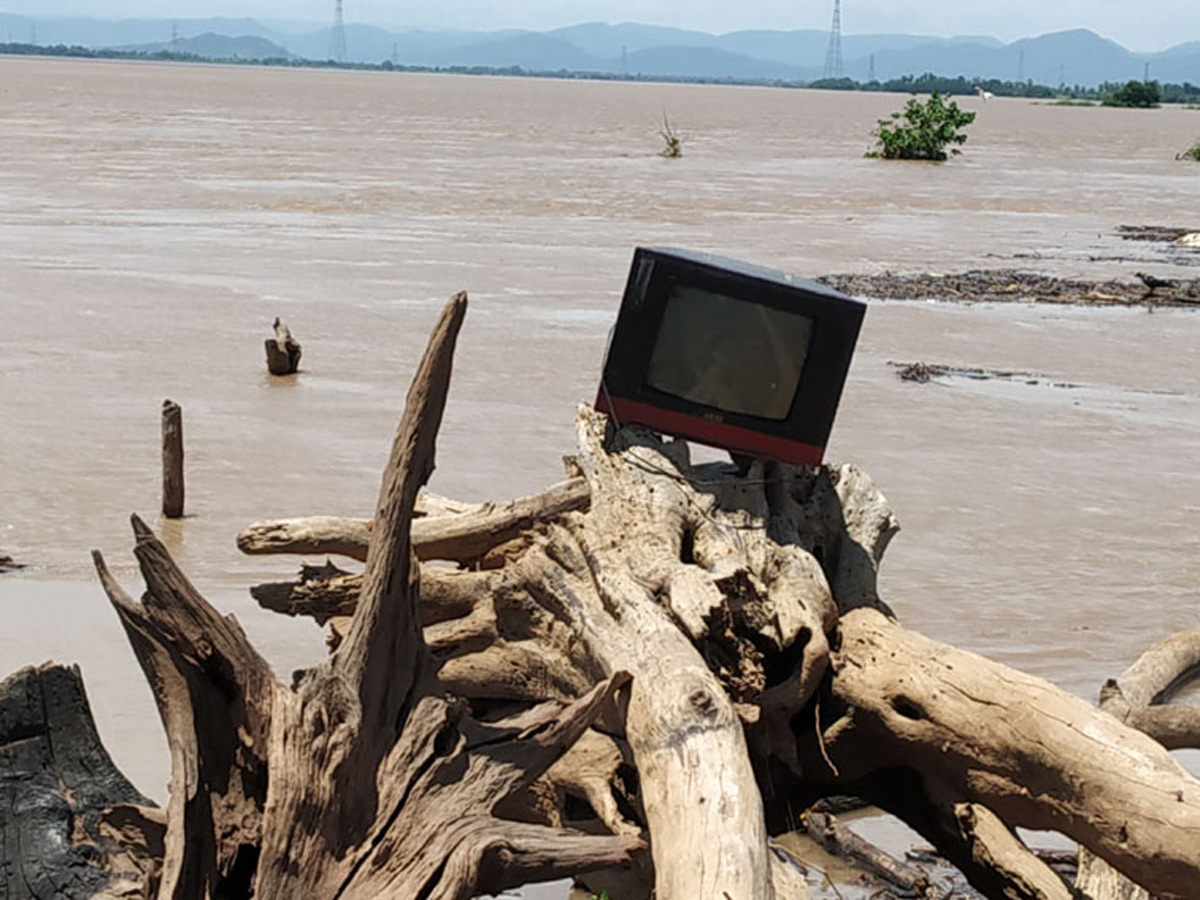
[229,297,1200,898]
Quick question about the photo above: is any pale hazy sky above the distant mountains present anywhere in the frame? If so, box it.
[0,0,1200,50]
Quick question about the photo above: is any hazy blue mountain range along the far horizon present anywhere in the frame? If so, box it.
[0,13,1200,85]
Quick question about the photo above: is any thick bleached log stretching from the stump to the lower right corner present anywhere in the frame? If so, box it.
[824,608,1200,900]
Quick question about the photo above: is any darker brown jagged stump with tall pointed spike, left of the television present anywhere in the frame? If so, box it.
[84,295,643,900]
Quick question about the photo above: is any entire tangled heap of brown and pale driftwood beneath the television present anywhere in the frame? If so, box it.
[7,292,1200,900]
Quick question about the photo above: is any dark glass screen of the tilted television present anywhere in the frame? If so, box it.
[646,284,812,421]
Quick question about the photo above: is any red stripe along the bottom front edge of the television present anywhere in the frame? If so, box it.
[596,391,824,466]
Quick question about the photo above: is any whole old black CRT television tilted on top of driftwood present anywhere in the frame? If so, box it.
[596,247,866,466]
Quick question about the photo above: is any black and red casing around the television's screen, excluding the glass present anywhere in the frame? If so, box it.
[595,247,866,466]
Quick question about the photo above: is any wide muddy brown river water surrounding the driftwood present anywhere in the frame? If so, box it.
[0,59,1200,900]
